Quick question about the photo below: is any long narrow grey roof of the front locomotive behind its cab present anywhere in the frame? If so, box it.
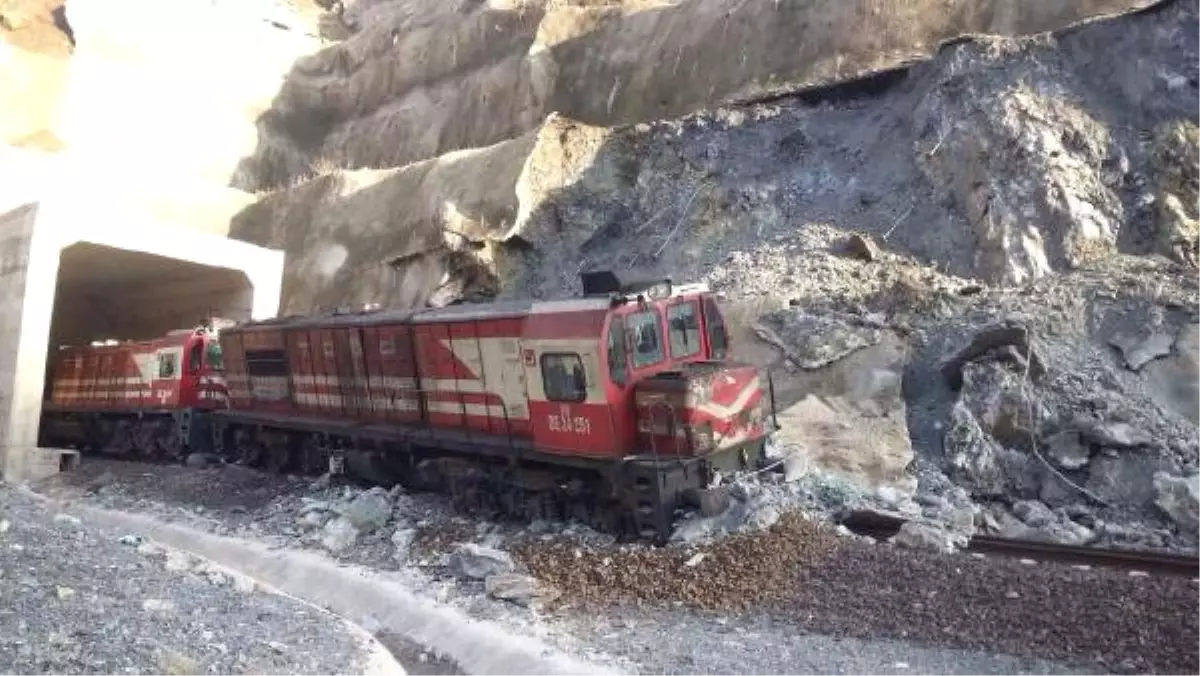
[234,298,610,329]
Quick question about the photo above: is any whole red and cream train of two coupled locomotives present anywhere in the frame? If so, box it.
[41,271,778,543]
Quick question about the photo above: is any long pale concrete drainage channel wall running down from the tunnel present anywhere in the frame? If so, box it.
[31,493,616,676]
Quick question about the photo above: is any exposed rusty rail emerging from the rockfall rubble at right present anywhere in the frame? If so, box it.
[841,512,1200,579]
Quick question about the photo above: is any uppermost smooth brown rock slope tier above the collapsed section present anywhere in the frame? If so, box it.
[239,0,1153,190]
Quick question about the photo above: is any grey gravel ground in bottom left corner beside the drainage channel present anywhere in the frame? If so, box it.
[0,484,382,674]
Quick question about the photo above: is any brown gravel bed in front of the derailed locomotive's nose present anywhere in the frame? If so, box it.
[518,514,1200,674]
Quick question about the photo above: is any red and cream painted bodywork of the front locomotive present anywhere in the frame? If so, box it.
[221,277,766,459]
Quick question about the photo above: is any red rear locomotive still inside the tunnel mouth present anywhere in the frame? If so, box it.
[38,327,228,460]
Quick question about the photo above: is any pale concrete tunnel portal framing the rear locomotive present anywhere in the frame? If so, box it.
[0,203,283,480]
